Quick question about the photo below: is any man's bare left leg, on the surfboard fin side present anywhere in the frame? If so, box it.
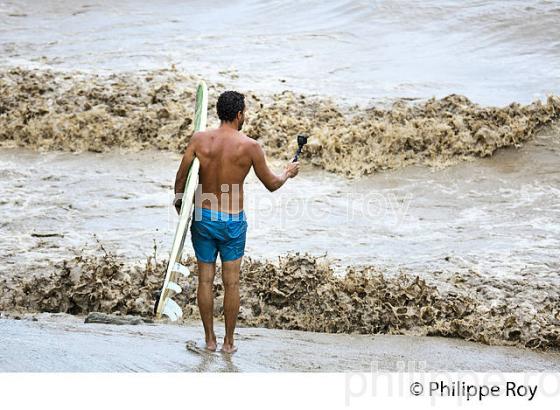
[196,261,217,351]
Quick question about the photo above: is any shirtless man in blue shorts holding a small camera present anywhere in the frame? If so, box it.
[175,91,299,353]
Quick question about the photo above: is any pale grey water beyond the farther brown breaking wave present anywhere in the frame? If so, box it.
[0,0,560,105]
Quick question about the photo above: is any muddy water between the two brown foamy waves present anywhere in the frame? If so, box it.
[0,128,560,282]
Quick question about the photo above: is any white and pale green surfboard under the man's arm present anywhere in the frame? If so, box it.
[154,81,208,321]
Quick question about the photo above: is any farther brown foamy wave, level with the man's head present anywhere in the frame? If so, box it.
[0,68,560,176]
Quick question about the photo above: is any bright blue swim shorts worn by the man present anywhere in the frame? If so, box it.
[191,208,247,263]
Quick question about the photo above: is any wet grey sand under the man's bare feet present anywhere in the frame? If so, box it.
[0,314,560,372]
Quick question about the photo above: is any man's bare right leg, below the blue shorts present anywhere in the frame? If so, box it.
[222,258,243,353]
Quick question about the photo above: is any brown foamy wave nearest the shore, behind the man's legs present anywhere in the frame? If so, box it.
[0,245,560,349]
